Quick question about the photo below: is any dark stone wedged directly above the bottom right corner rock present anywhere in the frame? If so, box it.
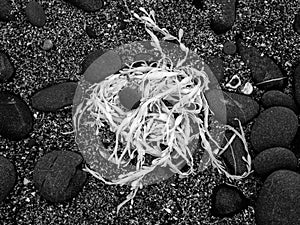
[253,147,297,177]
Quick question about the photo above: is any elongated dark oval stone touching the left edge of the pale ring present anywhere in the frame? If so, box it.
[31,82,77,112]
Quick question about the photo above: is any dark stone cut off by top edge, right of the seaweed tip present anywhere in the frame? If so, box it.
[210,0,236,34]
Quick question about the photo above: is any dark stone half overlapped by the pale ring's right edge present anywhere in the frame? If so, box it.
[205,90,259,126]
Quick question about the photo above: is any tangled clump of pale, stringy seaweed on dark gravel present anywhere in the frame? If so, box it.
[73,8,251,212]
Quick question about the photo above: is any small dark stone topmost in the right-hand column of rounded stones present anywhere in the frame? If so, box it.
[261,90,298,113]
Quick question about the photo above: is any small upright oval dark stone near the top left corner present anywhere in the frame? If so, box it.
[25,1,46,27]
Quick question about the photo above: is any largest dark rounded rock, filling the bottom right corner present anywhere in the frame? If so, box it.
[254,170,300,225]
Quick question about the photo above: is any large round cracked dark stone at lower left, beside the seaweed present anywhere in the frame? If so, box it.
[33,151,87,202]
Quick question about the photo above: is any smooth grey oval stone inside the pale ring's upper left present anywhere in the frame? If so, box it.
[84,50,122,84]
